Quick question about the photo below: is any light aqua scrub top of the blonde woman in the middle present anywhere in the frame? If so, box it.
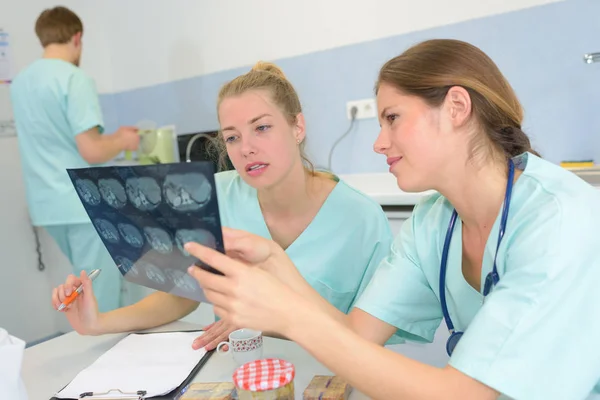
[215,171,393,313]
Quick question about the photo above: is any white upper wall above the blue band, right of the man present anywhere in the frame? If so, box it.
[96,0,560,91]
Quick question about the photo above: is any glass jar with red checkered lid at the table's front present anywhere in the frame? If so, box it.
[233,358,296,400]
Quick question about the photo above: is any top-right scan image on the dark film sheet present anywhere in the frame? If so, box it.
[163,172,213,211]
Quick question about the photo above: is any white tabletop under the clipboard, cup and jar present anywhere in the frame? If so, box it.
[22,322,367,400]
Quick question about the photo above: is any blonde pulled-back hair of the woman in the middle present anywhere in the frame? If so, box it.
[213,61,315,175]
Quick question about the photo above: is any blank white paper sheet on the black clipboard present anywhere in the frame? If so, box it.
[56,332,206,399]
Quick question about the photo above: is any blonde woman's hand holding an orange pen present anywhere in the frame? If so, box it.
[52,271,102,335]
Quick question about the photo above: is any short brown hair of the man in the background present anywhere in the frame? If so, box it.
[35,7,83,47]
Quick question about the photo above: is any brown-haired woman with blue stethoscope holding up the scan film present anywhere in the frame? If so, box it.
[188,40,600,400]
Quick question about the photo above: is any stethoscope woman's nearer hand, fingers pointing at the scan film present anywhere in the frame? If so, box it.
[185,235,303,336]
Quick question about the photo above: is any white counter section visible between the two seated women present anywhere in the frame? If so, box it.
[339,173,435,207]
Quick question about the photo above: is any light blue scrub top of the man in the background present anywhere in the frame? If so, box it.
[10,59,103,226]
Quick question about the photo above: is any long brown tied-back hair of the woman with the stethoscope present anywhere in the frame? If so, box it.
[375,39,539,158]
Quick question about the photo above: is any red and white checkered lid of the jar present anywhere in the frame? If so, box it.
[233,358,296,392]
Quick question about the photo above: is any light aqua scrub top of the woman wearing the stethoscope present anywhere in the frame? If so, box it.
[356,153,600,399]
